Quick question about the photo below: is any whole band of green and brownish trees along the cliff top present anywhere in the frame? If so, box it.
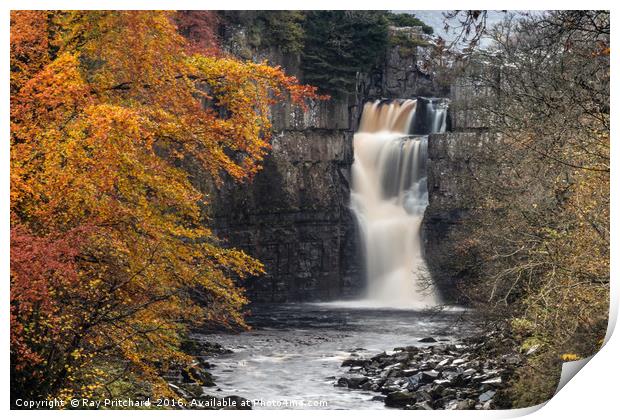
[219,10,433,96]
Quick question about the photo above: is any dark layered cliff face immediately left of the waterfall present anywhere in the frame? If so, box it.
[213,124,363,302]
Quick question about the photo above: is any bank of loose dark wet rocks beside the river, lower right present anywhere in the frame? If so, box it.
[336,332,524,410]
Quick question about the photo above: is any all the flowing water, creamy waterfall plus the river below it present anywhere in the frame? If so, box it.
[198,98,460,409]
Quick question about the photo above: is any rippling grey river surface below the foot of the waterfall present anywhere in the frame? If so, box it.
[196,304,473,409]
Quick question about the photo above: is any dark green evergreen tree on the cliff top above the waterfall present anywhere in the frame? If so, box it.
[302,11,388,96]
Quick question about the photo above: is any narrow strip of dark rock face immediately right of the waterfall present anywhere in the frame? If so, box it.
[422,63,500,302]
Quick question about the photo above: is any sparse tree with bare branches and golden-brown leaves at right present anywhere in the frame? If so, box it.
[444,11,610,406]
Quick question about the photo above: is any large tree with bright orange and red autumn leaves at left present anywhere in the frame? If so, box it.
[11,11,324,399]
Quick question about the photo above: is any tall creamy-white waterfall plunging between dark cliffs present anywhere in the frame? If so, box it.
[351,98,447,308]
